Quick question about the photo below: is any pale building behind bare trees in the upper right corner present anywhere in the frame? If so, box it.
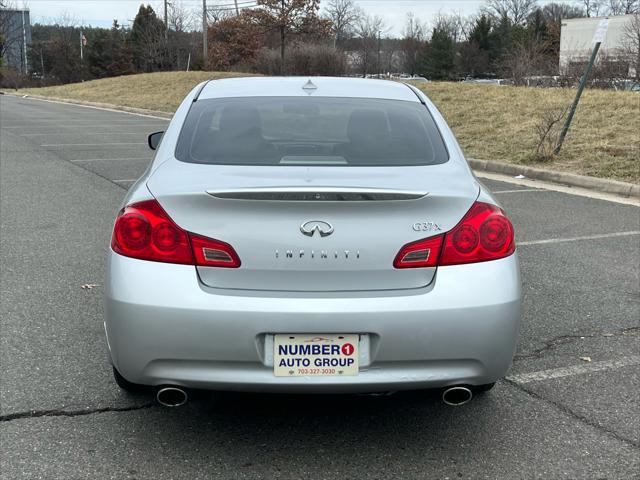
[559,15,636,78]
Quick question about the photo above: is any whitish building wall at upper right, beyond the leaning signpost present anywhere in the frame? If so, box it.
[560,15,635,76]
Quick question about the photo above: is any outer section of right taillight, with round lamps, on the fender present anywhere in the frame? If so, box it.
[438,202,516,265]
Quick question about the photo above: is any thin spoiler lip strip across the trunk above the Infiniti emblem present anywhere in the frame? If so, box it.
[206,187,429,202]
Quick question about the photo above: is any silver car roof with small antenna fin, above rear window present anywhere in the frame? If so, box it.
[198,77,420,102]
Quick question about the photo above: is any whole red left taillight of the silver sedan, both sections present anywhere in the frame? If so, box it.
[111,200,240,268]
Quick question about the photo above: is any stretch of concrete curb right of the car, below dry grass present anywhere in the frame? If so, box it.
[467,158,640,197]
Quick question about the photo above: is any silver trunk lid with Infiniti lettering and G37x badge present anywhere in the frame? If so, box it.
[148,161,478,292]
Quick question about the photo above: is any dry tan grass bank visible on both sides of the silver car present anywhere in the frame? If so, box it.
[13,72,640,183]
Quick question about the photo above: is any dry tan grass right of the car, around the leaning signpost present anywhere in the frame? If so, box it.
[419,83,640,183]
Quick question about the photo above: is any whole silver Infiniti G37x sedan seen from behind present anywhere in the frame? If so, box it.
[105,77,521,406]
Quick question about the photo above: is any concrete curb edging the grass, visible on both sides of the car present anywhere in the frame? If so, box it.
[0,92,640,198]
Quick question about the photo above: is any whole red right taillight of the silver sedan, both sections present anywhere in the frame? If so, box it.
[393,202,516,268]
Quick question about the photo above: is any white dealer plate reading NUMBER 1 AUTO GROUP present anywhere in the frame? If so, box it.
[273,333,358,377]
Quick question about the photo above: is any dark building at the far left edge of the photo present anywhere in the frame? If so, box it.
[0,8,31,74]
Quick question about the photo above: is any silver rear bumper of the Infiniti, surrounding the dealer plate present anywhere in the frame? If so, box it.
[105,252,521,392]
